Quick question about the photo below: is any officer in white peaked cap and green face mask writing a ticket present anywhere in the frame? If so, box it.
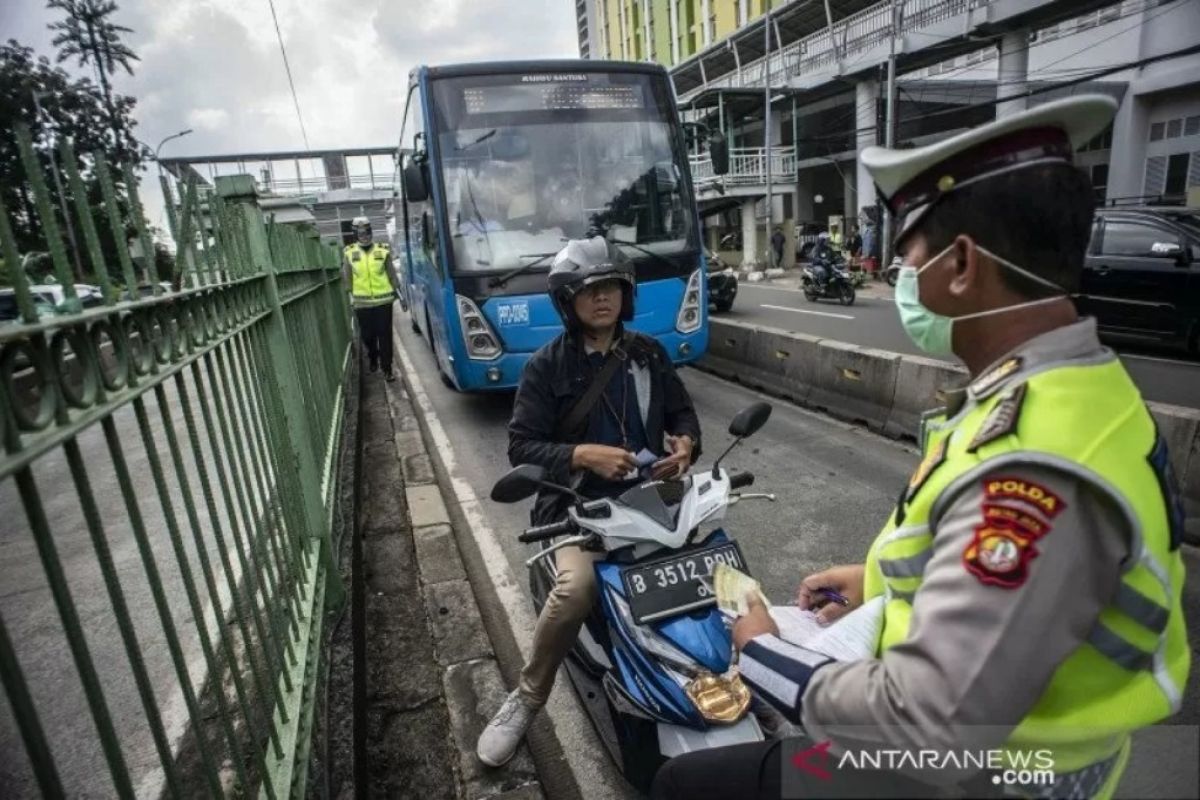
[655,95,1190,798]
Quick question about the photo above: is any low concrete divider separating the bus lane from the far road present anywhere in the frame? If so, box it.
[696,318,1200,545]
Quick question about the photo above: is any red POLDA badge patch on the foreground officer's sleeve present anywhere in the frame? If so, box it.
[962,477,1066,589]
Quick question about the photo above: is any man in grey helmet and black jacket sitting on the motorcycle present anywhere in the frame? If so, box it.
[476,236,700,766]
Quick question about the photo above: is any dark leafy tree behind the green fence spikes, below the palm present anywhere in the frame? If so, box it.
[0,40,146,286]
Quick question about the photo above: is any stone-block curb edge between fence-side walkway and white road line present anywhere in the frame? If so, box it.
[384,384,544,800]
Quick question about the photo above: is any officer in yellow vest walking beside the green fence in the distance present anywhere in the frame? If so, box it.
[342,217,400,380]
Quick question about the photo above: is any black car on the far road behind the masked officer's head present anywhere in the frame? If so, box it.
[1075,207,1200,354]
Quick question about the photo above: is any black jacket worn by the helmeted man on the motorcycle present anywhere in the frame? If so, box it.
[509,333,700,525]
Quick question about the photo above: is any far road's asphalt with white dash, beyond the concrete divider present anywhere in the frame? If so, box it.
[721,278,1200,408]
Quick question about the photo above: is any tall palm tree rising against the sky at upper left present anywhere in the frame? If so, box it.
[46,0,139,163]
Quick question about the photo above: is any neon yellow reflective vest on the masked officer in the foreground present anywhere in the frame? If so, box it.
[864,357,1190,798]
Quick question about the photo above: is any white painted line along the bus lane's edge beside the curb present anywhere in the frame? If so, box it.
[394,326,630,800]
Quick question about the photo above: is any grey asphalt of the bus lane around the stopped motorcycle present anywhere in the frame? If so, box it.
[396,316,1200,796]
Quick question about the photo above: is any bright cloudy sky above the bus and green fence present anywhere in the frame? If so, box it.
[0,0,578,222]
